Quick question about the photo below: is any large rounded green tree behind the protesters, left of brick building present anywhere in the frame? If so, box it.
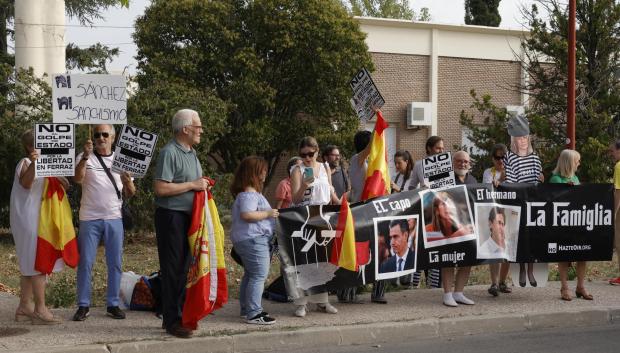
[134,0,373,179]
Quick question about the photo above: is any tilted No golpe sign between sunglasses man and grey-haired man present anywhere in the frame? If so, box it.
[112,125,157,178]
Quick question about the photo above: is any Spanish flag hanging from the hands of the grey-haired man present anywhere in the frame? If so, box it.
[183,191,228,330]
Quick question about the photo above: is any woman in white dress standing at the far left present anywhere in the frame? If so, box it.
[10,130,69,325]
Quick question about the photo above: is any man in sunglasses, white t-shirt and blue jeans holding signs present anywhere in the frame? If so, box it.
[73,124,136,321]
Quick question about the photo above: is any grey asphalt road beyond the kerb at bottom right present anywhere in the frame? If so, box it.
[272,325,620,353]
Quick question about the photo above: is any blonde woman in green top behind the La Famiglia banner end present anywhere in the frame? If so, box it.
[549,150,594,301]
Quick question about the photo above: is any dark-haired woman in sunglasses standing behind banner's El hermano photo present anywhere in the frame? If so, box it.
[482,143,512,297]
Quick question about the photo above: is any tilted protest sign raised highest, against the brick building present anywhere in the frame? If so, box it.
[349,69,385,122]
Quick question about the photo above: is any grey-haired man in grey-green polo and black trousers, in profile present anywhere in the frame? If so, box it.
[153,109,209,338]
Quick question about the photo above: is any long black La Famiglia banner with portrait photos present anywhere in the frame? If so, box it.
[276,184,614,293]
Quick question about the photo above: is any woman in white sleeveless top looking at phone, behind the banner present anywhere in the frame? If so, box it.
[291,136,340,317]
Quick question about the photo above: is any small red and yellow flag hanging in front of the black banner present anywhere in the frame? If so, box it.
[329,197,359,271]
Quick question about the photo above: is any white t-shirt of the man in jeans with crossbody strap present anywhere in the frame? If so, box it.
[77,153,123,221]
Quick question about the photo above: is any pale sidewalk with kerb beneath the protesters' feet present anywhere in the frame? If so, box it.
[0,281,620,353]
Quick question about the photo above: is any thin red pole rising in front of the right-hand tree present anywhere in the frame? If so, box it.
[566,0,577,150]
